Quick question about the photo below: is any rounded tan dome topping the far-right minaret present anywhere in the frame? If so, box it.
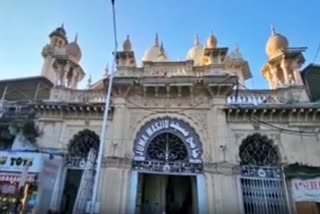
[266,27,289,58]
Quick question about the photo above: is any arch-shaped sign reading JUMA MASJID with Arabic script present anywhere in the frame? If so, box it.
[134,117,202,163]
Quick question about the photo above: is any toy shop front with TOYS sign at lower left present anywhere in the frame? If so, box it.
[0,151,63,213]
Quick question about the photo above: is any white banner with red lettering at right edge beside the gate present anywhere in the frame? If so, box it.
[291,177,320,202]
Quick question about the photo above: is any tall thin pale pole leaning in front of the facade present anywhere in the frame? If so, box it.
[90,0,118,214]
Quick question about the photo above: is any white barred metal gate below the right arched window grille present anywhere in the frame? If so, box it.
[240,166,289,214]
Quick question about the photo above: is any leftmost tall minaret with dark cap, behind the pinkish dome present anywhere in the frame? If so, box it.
[41,25,68,83]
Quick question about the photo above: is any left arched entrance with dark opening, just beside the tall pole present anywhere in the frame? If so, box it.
[61,129,100,214]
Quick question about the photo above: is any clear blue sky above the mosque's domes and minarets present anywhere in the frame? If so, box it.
[0,0,320,88]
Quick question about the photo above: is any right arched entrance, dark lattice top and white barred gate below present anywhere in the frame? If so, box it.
[239,133,289,214]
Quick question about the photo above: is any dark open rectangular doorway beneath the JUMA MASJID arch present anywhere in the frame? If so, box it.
[136,173,198,214]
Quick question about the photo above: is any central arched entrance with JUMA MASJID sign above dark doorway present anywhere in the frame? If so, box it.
[132,117,203,214]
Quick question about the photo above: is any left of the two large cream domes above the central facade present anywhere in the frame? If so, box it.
[142,34,168,62]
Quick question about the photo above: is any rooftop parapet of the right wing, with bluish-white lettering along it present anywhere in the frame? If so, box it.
[226,86,309,105]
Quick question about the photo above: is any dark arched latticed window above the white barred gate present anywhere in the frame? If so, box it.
[239,133,280,166]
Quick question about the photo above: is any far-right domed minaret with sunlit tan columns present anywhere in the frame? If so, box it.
[261,27,306,89]
